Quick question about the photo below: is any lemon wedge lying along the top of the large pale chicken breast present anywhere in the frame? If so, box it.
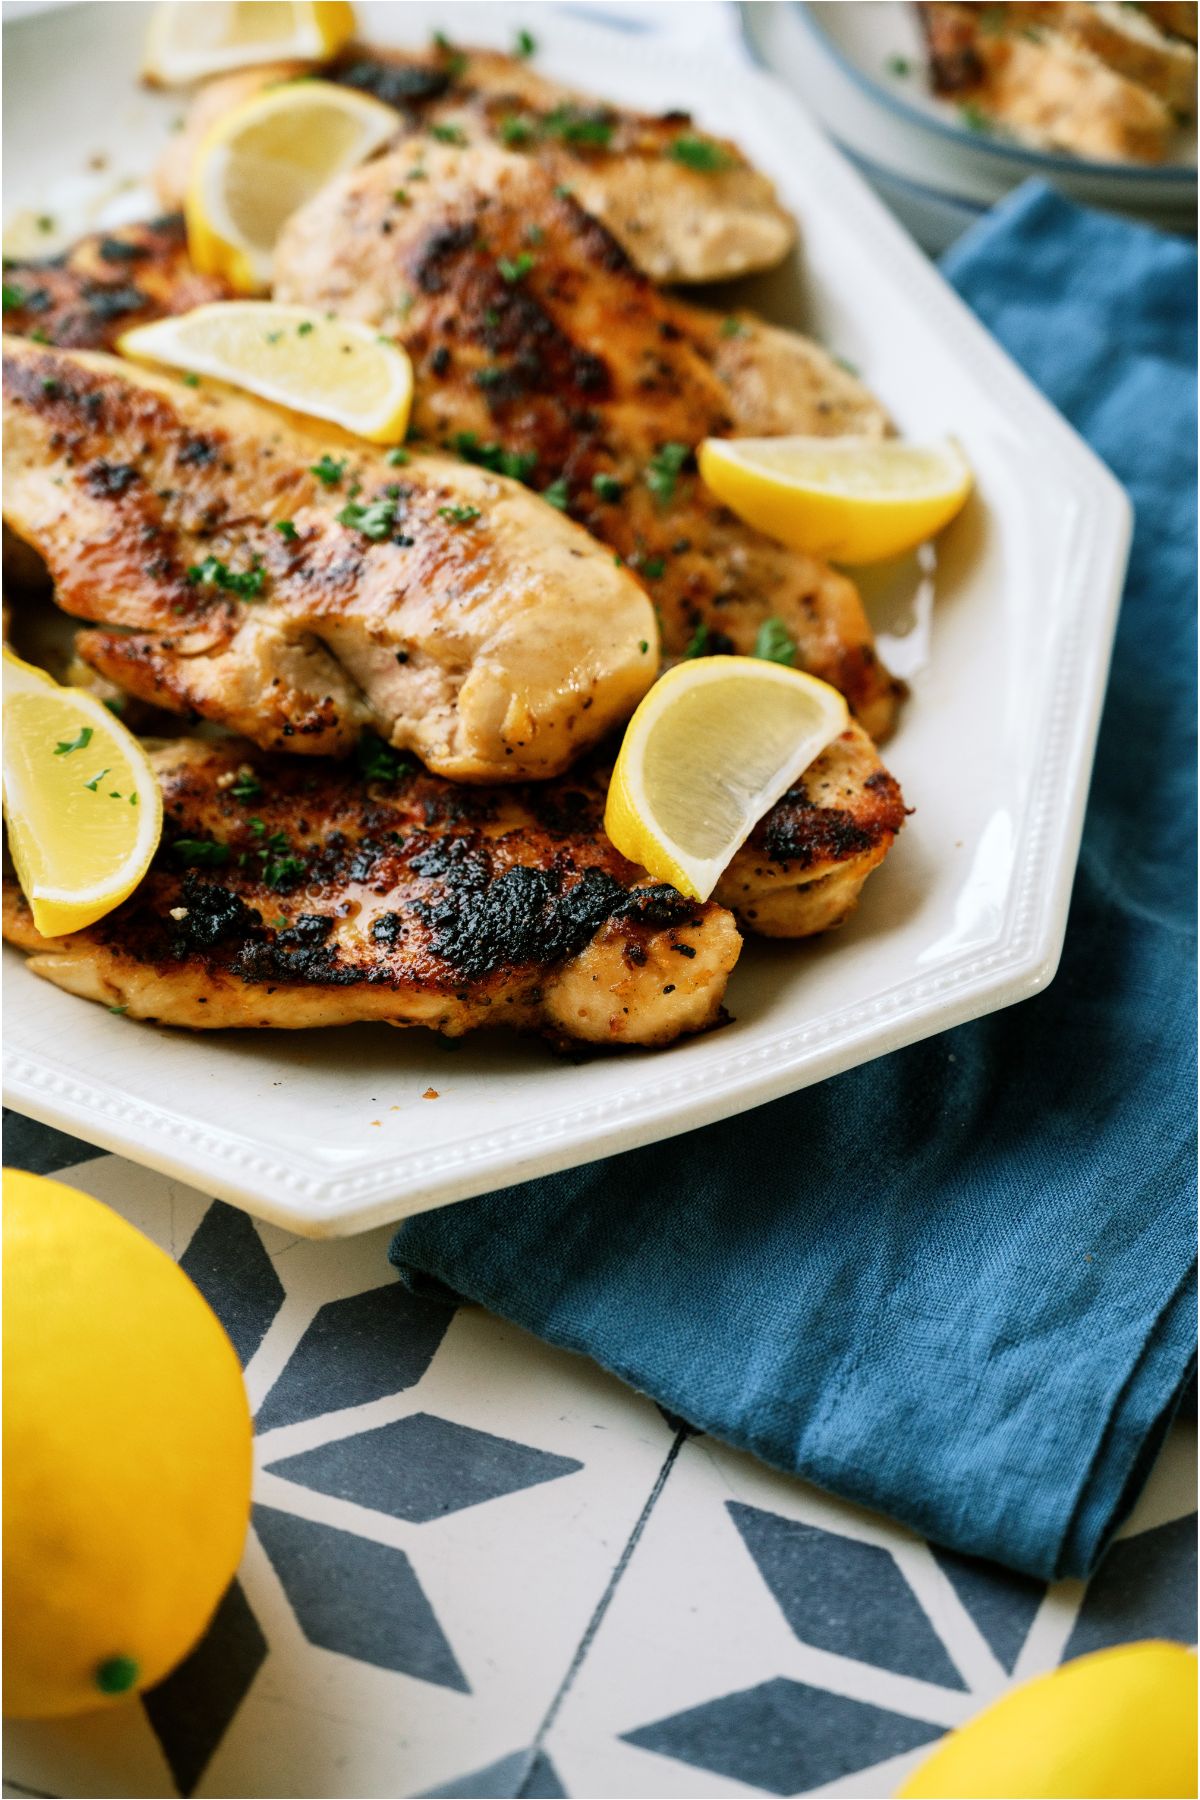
[117,301,412,445]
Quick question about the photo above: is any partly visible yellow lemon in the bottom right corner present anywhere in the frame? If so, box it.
[898,1642,1196,1800]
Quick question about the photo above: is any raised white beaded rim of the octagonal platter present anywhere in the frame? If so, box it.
[4,0,1132,1237]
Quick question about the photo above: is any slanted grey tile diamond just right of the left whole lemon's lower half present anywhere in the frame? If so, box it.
[254,1507,471,1694]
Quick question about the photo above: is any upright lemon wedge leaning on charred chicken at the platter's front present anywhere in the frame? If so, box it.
[604,657,849,900]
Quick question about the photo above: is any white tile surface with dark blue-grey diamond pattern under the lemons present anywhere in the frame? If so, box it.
[5,1116,1196,1800]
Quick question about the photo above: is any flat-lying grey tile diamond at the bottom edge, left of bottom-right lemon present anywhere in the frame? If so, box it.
[622,1676,943,1795]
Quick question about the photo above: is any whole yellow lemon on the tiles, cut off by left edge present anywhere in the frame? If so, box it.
[4,1170,250,1717]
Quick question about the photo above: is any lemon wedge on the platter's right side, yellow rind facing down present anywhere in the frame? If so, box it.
[698,437,972,563]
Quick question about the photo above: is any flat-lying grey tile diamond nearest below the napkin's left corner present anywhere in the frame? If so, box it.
[268,1413,583,1525]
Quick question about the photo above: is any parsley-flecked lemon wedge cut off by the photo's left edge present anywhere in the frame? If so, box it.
[4,648,162,938]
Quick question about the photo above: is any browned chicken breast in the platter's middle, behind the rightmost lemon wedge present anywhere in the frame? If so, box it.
[275,140,900,738]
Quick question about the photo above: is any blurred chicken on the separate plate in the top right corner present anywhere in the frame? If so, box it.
[918,0,1196,162]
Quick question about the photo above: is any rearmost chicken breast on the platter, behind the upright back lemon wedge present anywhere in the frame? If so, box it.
[158,45,795,283]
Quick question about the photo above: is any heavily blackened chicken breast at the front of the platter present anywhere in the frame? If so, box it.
[4,740,741,1044]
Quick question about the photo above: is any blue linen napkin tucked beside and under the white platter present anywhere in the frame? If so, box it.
[390,185,1196,1579]
